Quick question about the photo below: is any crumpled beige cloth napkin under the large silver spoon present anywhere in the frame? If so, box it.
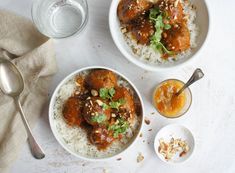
[0,10,57,173]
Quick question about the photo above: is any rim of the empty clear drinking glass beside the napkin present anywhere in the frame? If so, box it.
[31,0,89,39]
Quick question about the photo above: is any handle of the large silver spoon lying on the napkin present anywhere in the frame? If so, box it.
[15,98,45,159]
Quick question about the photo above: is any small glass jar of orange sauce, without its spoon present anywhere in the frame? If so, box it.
[153,79,192,118]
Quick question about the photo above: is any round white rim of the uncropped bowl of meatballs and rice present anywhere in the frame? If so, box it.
[49,66,145,161]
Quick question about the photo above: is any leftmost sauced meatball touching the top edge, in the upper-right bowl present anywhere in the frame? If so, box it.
[117,0,153,24]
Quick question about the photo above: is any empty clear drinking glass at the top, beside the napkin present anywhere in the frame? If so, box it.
[32,0,88,39]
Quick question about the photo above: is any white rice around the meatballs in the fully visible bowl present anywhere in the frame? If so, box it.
[52,70,142,158]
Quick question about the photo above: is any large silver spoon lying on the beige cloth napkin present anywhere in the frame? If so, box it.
[0,58,45,159]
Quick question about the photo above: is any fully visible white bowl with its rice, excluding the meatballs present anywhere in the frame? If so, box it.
[49,66,144,161]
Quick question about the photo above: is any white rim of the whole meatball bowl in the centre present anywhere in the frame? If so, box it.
[49,66,144,161]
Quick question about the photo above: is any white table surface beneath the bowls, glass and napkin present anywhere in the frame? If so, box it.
[0,0,235,173]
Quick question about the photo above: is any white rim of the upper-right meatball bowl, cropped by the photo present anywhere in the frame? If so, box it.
[109,0,210,72]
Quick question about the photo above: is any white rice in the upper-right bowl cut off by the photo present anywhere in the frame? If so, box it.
[121,0,199,65]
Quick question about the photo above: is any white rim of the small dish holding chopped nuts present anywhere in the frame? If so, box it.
[153,123,195,165]
